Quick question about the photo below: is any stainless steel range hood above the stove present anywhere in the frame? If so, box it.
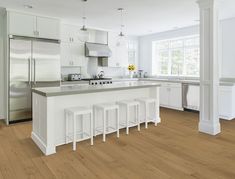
[85,42,112,57]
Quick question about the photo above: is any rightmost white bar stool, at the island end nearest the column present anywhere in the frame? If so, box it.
[136,98,158,128]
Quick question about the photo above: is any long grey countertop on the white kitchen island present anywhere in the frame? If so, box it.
[32,81,161,97]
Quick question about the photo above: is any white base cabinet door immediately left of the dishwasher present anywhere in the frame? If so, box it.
[169,87,182,109]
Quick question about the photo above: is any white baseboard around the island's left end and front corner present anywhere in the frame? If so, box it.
[31,132,56,155]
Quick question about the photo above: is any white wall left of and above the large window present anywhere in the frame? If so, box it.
[139,26,199,75]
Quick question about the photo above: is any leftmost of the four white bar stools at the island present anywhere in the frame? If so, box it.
[65,107,93,150]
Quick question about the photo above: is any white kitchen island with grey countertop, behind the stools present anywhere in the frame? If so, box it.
[32,81,160,155]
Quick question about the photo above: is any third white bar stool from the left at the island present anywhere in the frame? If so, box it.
[117,100,140,134]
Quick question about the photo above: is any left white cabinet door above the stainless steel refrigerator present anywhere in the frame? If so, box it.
[8,12,36,37]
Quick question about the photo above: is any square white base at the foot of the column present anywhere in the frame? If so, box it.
[198,122,221,135]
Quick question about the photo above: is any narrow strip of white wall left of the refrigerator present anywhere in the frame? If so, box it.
[0,9,4,119]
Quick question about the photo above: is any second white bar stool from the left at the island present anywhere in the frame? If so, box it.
[94,103,119,142]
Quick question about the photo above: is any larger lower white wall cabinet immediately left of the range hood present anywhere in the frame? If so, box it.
[60,43,86,67]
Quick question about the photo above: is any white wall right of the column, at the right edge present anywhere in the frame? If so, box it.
[220,18,235,78]
